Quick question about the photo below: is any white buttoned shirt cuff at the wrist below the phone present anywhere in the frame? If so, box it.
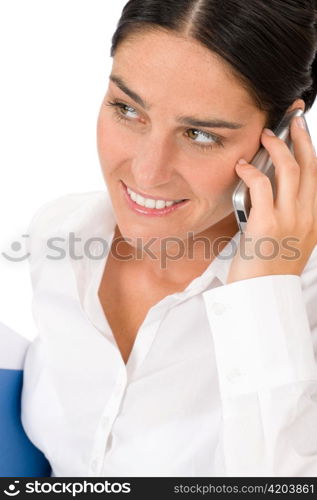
[203,275,317,398]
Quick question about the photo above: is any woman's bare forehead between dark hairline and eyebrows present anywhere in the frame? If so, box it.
[112,30,256,117]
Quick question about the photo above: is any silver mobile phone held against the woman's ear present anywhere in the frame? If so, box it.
[232,109,309,233]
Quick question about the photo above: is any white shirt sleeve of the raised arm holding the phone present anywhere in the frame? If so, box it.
[203,268,317,477]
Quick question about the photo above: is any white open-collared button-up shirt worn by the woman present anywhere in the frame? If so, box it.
[22,192,317,477]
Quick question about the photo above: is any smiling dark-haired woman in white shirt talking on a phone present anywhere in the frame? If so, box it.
[23,0,317,476]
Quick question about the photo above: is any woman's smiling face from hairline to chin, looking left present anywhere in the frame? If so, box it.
[97,31,266,245]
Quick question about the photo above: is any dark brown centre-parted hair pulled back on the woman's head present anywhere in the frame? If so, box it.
[111,0,317,127]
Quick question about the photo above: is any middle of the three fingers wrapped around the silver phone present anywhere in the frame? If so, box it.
[261,129,300,216]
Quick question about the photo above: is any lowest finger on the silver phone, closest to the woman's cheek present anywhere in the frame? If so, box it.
[236,159,274,220]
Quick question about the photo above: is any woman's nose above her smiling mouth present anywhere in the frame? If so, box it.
[131,130,176,192]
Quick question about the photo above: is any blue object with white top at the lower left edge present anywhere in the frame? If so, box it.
[0,324,51,477]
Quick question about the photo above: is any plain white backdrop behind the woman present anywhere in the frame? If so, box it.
[0,0,317,339]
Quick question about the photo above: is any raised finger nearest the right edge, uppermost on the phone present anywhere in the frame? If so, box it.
[291,118,317,210]
